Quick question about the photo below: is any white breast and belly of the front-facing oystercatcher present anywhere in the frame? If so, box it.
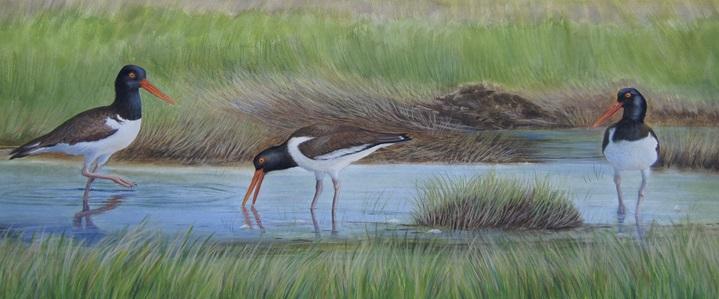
[604,128,659,170]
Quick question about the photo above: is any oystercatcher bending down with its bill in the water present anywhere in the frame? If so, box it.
[242,125,410,230]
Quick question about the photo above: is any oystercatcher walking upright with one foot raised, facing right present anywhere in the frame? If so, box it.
[10,65,175,188]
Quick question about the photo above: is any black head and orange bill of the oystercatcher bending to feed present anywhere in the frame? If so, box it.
[242,143,297,206]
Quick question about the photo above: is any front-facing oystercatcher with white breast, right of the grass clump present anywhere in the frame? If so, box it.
[592,88,659,216]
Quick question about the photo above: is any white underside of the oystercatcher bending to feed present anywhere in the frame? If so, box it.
[287,137,392,177]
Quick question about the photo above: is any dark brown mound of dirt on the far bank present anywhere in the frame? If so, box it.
[427,85,560,129]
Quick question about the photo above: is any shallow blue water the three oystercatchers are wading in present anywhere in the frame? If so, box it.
[0,130,719,240]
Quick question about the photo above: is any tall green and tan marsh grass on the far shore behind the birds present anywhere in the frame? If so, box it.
[0,0,719,162]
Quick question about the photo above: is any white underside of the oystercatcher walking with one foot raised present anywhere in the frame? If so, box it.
[32,115,142,163]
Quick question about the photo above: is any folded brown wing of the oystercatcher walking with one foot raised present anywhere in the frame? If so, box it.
[10,106,119,158]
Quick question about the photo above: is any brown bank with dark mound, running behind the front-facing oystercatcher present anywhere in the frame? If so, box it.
[421,84,719,130]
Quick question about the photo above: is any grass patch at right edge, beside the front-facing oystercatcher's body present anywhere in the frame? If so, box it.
[657,128,719,170]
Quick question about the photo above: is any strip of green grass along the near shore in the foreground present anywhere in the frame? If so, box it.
[0,228,719,298]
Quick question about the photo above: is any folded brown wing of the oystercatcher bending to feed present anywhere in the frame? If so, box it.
[292,125,410,159]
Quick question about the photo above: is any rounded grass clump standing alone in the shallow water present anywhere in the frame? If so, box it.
[414,173,582,230]
